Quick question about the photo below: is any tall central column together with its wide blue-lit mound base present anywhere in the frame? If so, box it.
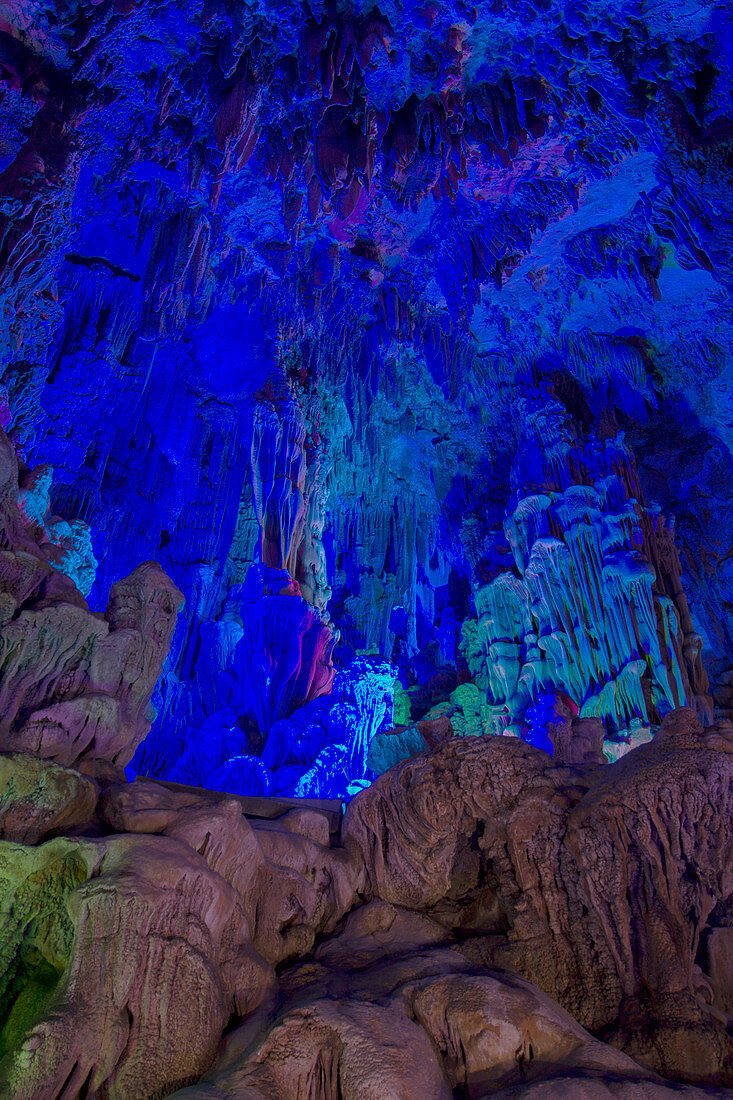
[129,391,396,798]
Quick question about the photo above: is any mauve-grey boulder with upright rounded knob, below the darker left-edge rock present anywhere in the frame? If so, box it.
[0,562,183,767]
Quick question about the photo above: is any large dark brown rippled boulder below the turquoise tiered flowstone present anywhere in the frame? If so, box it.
[343,710,733,1084]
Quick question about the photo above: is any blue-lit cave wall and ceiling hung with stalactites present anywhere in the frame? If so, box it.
[0,0,733,787]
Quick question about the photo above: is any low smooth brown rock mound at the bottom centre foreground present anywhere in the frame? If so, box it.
[165,946,654,1100]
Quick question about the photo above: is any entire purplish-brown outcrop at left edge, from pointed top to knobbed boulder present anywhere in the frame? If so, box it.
[0,429,183,771]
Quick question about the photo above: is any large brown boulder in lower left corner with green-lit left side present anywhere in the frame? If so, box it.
[0,836,263,1100]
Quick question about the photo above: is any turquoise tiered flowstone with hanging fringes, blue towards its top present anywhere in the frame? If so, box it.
[462,398,712,741]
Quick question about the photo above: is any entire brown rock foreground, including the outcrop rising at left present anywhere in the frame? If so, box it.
[0,424,733,1100]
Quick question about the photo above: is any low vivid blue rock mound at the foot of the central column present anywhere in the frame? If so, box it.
[129,642,396,799]
